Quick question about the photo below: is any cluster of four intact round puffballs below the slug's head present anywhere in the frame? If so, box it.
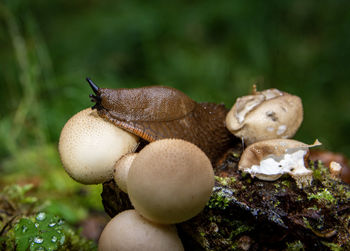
[59,108,214,251]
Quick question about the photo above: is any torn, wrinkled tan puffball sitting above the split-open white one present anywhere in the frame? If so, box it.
[226,89,303,145]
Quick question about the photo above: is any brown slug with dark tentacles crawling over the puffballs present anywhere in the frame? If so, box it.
[86,78,234,163]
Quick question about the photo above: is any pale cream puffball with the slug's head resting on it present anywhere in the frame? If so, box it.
[58,108,138,184]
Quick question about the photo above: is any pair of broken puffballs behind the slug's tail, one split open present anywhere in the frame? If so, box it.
[226,86,321,187]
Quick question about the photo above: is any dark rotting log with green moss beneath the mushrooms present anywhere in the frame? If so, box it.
[102,148,350,250]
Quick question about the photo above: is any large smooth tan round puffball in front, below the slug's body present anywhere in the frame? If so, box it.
[127,139,214,224]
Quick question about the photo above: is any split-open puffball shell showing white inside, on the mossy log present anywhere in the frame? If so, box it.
[238,139,321,187]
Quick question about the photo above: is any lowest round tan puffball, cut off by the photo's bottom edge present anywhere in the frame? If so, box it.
[98,210,184,251]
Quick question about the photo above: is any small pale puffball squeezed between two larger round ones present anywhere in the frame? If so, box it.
[114,153,137,193]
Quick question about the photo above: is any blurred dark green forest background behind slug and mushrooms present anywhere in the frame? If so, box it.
[0,0,350,230]
